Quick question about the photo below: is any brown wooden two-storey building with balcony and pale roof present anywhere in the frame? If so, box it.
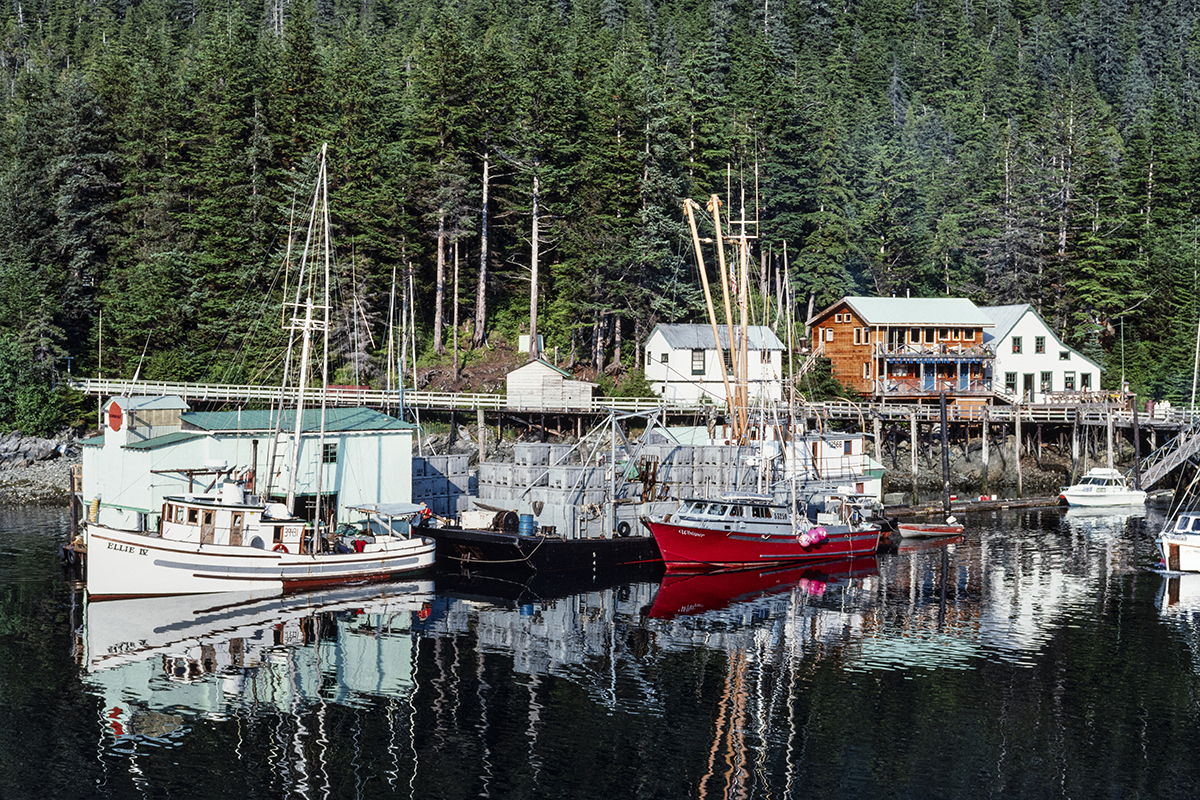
[809,297,996,405]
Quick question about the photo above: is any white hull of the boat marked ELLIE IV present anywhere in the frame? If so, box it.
[86,524,434,600]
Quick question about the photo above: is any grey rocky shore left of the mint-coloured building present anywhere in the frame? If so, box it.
[0,431,79,505]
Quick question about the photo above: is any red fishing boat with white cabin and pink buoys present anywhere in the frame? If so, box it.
[642,494,880,570]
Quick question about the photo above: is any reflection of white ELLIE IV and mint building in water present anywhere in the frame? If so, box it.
[79,581,433,741]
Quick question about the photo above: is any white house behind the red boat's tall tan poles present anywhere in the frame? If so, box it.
[646,323,784,405]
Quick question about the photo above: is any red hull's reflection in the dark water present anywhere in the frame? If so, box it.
[649,555,878,619]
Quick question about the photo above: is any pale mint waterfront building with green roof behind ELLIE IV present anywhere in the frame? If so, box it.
[80,397,414,529]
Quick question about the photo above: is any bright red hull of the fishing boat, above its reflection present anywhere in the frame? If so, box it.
[644,519,880,570]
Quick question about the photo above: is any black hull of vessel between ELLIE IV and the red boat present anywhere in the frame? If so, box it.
[412,528,662,572]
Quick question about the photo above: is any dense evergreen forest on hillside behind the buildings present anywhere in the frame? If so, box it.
[0,0,1200,431]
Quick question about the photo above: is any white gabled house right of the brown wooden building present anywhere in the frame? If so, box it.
[982,302,1100,403]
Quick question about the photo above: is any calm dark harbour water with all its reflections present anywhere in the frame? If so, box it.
[0,509,1200,800]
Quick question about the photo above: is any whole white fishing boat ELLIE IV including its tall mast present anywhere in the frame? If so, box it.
[85,150,434,600]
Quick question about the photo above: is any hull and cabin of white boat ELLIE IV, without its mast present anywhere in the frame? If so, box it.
[88,483,434,600]
